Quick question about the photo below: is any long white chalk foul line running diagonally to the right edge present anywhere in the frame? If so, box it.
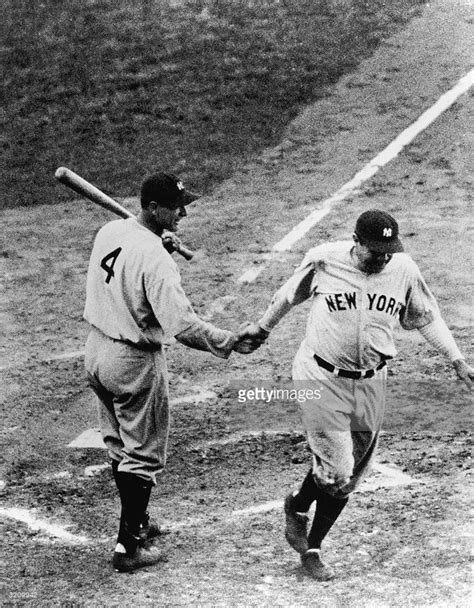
[237,69,474,283]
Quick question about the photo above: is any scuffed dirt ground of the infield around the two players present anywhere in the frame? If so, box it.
[0,0,474,608]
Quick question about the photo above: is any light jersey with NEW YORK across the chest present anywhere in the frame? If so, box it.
[277,241,439,370]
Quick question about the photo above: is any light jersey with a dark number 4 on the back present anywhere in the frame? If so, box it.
[84,218,199,347]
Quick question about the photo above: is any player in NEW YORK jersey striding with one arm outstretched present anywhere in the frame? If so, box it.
[243,209,474,581]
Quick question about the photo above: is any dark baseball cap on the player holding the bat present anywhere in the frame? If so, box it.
[140,172,199,209]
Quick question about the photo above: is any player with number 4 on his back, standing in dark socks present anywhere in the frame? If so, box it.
[84,173,263,571]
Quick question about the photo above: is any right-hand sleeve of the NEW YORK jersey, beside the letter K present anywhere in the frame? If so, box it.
[400,261,440,329]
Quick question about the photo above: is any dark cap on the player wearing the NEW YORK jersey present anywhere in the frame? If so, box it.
[355,209,403,253]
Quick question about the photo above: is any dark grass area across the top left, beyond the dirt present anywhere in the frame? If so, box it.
[1,0,422,207]
